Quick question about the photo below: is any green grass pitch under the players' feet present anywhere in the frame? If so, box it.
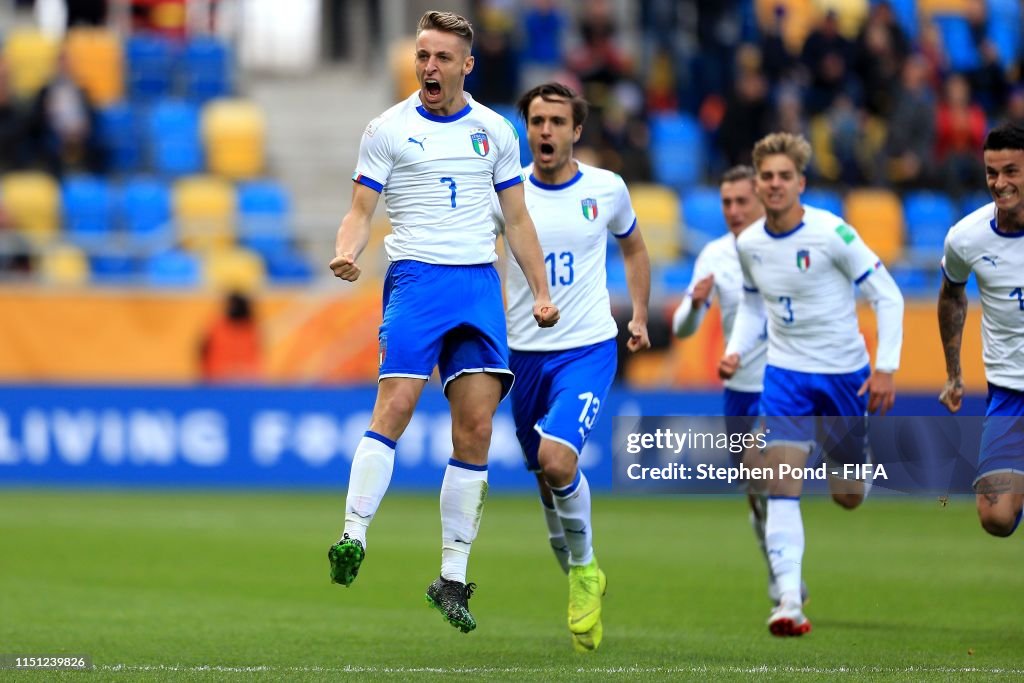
[0,490,1024,680]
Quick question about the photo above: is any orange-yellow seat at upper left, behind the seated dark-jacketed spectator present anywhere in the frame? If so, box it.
[65,27,125,106]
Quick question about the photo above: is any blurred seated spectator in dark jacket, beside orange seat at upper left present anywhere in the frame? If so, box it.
[28,50,103,176]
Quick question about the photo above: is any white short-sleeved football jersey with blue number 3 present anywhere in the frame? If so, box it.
[736,205,882,375]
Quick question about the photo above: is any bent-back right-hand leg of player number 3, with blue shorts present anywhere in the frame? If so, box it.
[814,366,871,510]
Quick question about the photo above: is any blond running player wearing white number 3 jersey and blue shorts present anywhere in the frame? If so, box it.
[719,133,903,636]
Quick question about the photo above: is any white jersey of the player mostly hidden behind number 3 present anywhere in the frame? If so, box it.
[687,228,768,392]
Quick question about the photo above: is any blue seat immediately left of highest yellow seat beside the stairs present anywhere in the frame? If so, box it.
[146,99,204,177]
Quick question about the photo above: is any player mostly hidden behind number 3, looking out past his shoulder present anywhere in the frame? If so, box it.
[672,166,806,603]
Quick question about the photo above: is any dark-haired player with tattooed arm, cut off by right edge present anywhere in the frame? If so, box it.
[939,125,1024,536]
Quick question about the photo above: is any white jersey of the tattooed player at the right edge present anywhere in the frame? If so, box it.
[942,204,1024,391]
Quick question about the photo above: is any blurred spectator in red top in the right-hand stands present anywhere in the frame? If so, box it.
[935,74,986,197]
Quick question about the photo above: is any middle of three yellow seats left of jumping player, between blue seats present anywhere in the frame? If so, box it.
[172,175,237,251]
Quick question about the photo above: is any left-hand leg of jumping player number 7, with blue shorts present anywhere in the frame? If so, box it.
[328,261,444,586]
